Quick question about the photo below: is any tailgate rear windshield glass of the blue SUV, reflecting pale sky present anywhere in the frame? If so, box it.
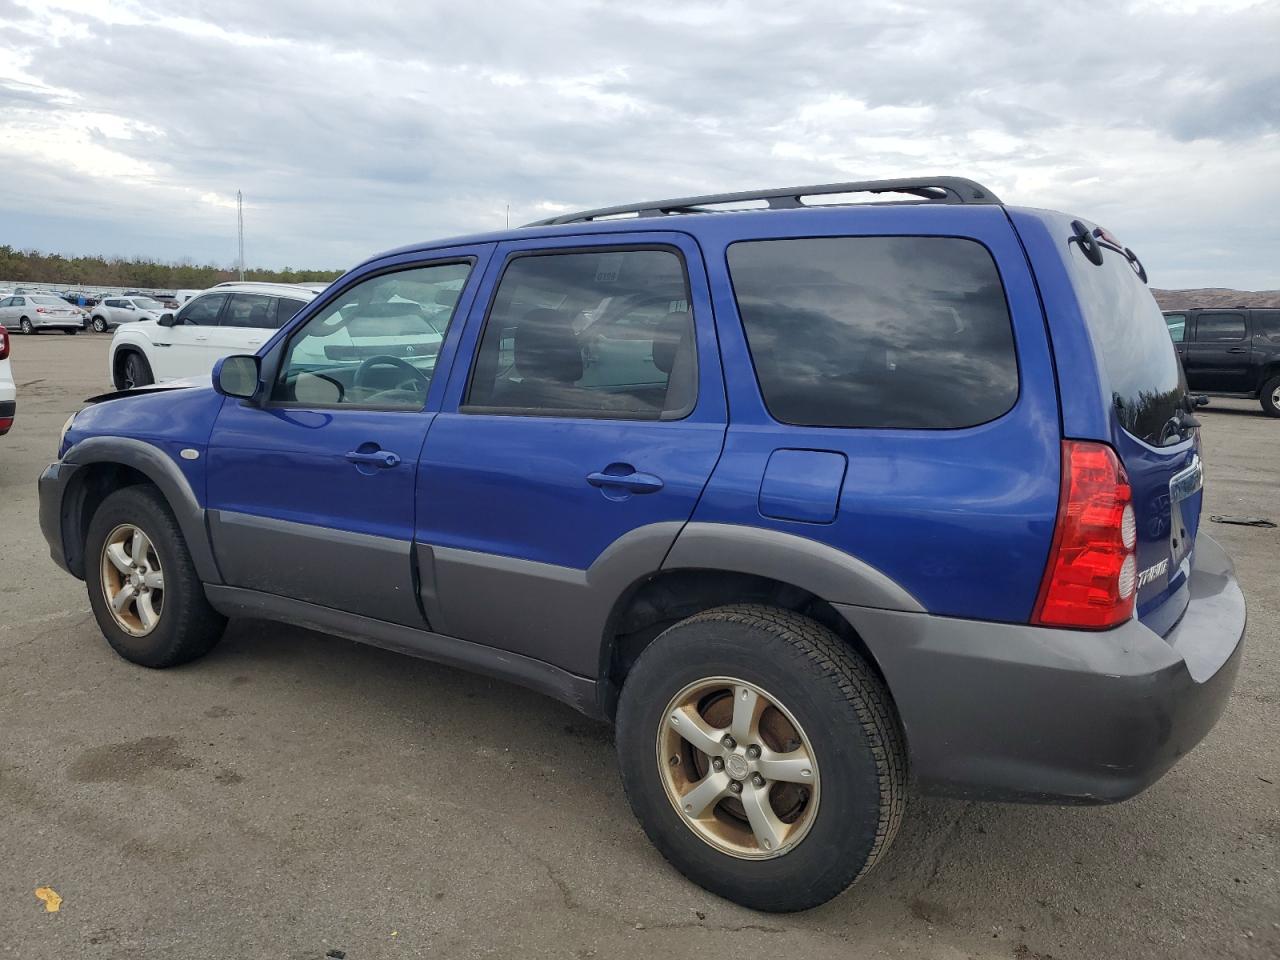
[1062,232,1182,447]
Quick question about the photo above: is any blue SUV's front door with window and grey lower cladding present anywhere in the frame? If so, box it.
[207,246,492,627]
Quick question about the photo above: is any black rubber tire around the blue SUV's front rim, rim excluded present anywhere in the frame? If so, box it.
[84,484,227,668]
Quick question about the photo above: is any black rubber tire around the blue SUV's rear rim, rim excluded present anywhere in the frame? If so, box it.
[617,604,908,913]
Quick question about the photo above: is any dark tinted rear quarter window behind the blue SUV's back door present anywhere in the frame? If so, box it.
[728,237,1018,429]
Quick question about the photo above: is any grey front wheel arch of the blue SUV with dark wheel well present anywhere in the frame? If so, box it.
[60,436,221,584]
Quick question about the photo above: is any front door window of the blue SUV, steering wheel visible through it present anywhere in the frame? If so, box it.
[271,261,471,410]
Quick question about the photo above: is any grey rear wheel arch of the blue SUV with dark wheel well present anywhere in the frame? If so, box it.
[596,524,923,718]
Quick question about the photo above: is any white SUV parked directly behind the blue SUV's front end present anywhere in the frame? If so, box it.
[109,283,317,390]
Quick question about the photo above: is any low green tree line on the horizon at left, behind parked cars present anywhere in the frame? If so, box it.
[0,244,343,289]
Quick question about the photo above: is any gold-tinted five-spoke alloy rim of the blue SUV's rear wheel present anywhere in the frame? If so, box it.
[657,677,819,860]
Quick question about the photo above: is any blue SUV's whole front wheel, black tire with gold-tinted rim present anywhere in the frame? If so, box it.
[84,484,227,667]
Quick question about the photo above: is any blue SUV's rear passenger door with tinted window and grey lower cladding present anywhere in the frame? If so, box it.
[417,233,726,677]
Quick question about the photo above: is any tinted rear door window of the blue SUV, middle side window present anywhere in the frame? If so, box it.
[462,248,698,420]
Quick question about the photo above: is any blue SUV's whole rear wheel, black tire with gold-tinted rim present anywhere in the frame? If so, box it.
[617,605,906,911]
